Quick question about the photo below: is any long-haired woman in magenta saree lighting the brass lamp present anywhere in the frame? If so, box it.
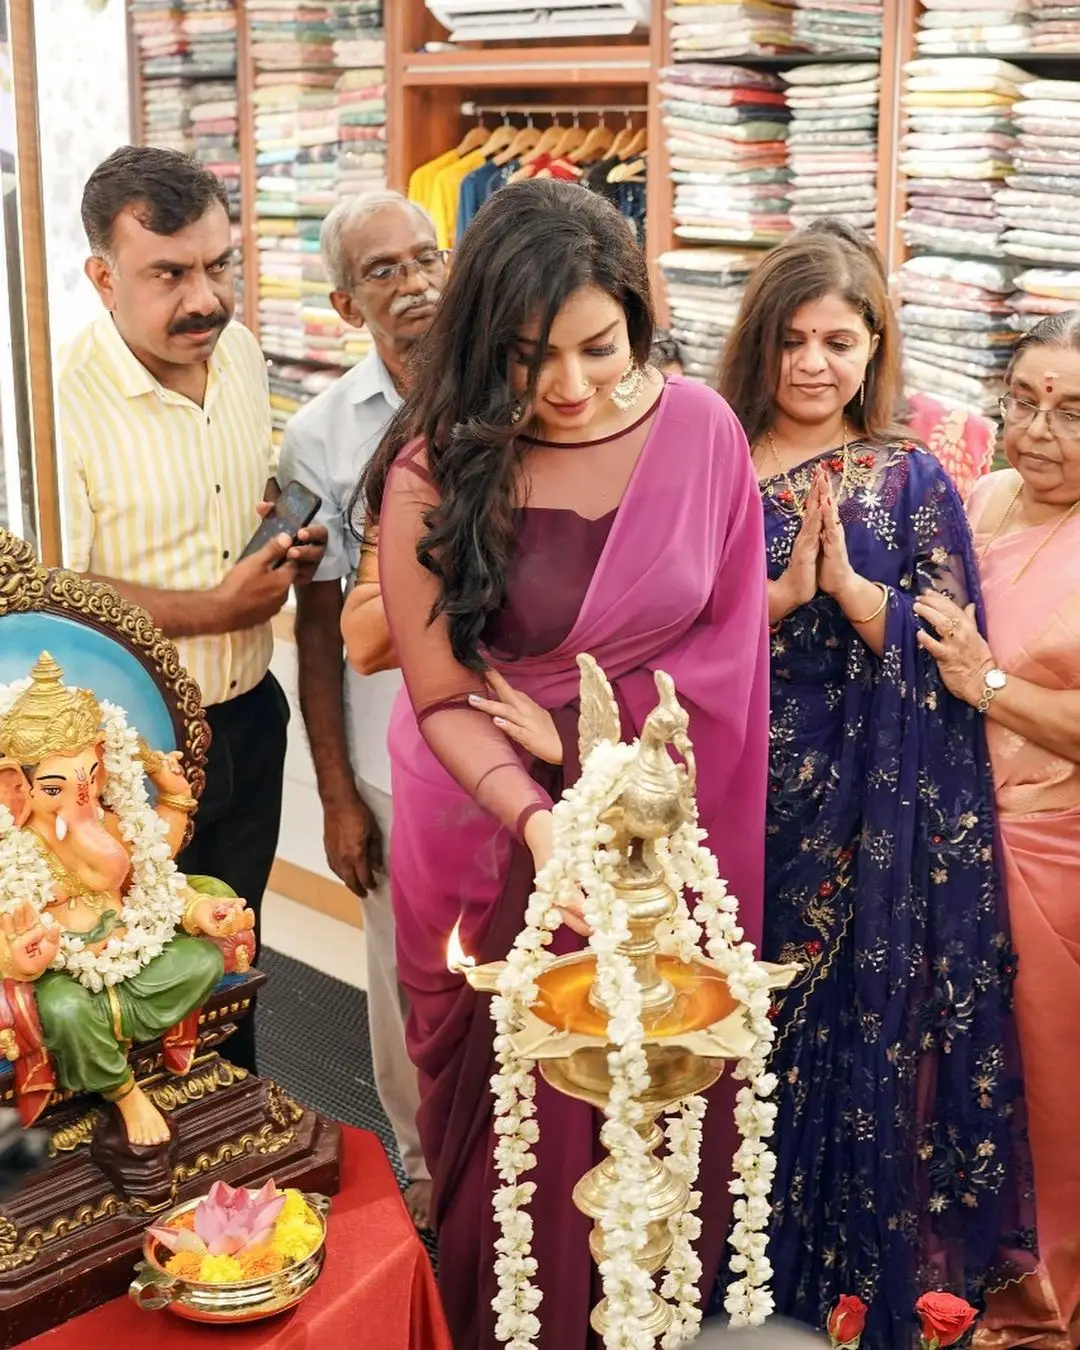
[365,181,768,1350]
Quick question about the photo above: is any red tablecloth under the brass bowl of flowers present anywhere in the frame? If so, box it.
[23,1129,452,1350]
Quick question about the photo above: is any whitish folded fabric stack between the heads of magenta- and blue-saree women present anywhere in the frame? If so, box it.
[660,248,760,383]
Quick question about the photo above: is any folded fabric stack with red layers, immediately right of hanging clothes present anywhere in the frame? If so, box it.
[660,63,791,246]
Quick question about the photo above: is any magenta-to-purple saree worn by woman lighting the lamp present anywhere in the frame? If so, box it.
[379,379,768,1350]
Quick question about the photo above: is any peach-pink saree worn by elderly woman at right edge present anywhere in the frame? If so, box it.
[968,470,1080,1350]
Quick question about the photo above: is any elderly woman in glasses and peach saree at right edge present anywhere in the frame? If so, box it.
[915,311,1080,1350]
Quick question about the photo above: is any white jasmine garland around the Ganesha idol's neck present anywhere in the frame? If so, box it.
[0,679,185,992]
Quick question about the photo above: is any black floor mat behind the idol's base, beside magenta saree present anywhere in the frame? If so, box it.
[258,948,435,1260]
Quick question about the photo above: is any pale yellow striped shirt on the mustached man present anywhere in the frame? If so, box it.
[57,313,275,705]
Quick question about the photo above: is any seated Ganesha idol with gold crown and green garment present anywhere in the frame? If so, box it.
[0,652,254,1152]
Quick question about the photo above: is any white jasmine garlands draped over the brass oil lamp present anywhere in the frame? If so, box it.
[491,740,776,1350]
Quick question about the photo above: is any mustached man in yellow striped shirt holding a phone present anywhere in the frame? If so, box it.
[58,146,325,1071]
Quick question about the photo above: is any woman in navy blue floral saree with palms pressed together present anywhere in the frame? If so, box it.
[720,231,1034,1350]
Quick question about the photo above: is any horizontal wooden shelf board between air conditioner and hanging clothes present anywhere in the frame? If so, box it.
[396,45,651,89]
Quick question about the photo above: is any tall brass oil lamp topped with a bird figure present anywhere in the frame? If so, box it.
[450,656,797,1339]
